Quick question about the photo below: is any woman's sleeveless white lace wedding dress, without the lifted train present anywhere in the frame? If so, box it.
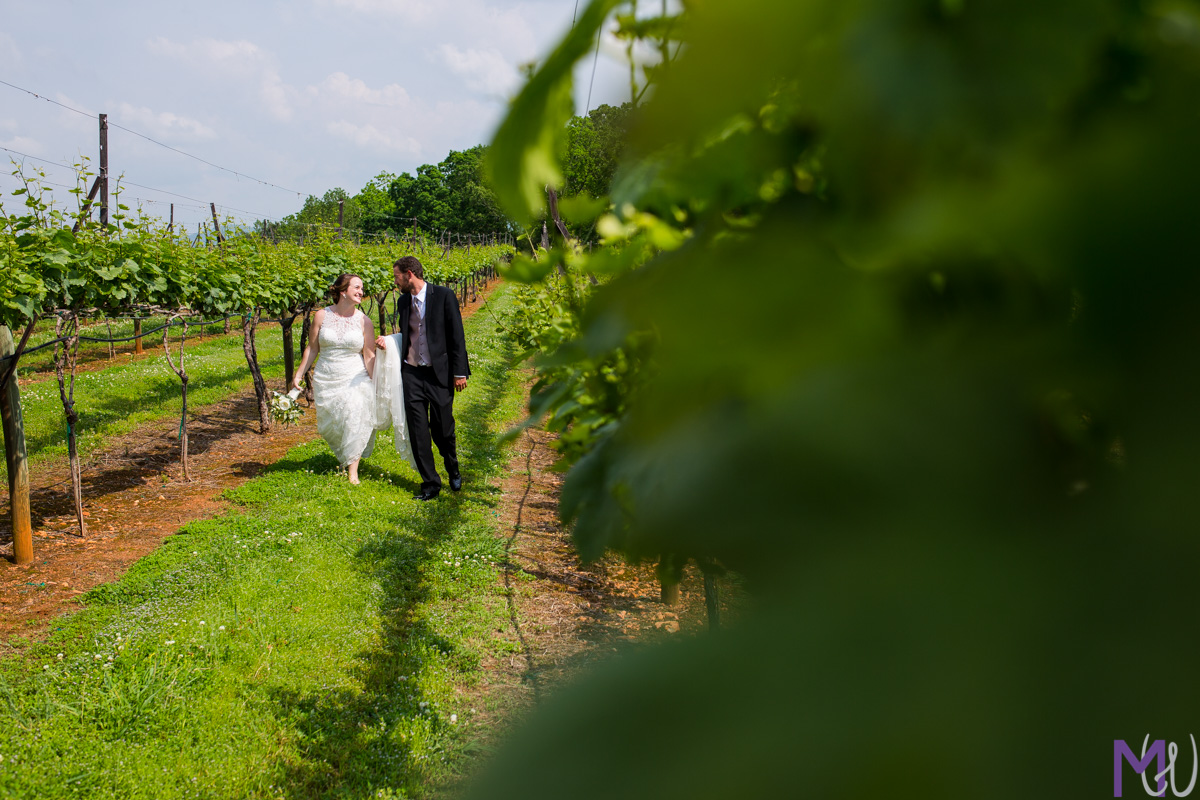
[312,306,376,467]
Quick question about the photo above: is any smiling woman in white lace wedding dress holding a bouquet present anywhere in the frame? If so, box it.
[292,272,374,483]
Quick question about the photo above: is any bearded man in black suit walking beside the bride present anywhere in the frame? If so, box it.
[376,255,470,500]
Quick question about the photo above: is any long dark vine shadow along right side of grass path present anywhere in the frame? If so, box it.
[275,316,523,799]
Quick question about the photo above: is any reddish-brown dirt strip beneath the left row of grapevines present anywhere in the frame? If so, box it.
[0,283,497,657]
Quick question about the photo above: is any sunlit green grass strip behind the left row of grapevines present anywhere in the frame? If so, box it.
[0,325,286,480]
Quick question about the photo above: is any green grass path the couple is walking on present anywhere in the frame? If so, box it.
[0,288,522,799]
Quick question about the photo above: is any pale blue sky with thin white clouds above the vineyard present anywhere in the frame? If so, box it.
[0,0,629,229]
